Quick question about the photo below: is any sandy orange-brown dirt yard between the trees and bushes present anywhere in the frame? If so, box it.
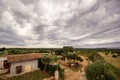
[57,56,88,80]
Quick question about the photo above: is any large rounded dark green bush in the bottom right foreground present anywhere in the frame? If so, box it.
[85,62,116,80]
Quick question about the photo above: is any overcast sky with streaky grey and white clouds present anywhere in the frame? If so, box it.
[0,0,120,48]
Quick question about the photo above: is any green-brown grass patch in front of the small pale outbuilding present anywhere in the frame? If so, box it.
[7,70,49,80]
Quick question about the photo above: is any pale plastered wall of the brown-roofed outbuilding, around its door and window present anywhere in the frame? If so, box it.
[10,59,38,74]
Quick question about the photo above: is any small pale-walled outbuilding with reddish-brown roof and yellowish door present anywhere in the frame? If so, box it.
[7,53,41,74]
